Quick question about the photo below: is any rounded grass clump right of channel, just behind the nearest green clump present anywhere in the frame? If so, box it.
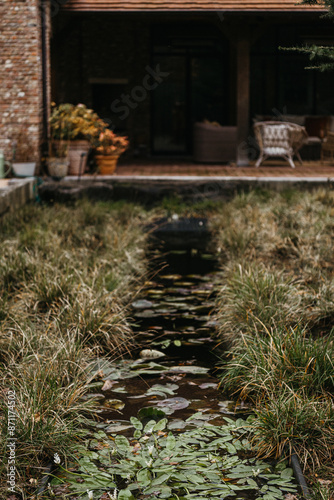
[216,262,305,342]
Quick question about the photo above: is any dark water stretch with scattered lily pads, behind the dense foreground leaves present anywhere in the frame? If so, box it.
[91,250,242,431]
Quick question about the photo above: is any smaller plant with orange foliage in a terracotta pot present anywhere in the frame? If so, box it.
[94,123,129,175]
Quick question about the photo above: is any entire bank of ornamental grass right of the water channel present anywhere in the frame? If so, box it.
[213,188,334,480]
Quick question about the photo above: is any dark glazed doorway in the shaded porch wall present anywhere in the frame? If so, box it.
[151,26,228,156]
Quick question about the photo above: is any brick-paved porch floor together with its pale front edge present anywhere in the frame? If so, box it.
[39,161,334,205]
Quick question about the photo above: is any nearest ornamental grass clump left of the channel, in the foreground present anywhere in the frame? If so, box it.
[0,321,94,498]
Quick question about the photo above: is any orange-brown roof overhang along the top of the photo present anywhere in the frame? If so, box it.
[62,0,326,13]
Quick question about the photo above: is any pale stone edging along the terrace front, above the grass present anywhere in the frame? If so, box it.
[39,175,334,202]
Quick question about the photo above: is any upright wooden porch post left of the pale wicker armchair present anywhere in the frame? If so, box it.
[236,30,250,166]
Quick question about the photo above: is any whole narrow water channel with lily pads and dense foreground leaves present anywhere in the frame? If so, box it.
[54,233,296,500]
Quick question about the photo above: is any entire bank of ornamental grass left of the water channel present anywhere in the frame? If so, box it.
[0,201,150,500]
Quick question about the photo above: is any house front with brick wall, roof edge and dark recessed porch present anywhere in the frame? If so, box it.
[0,0,334,168]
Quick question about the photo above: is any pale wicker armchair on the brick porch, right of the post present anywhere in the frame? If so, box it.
[254,121,307,168]
